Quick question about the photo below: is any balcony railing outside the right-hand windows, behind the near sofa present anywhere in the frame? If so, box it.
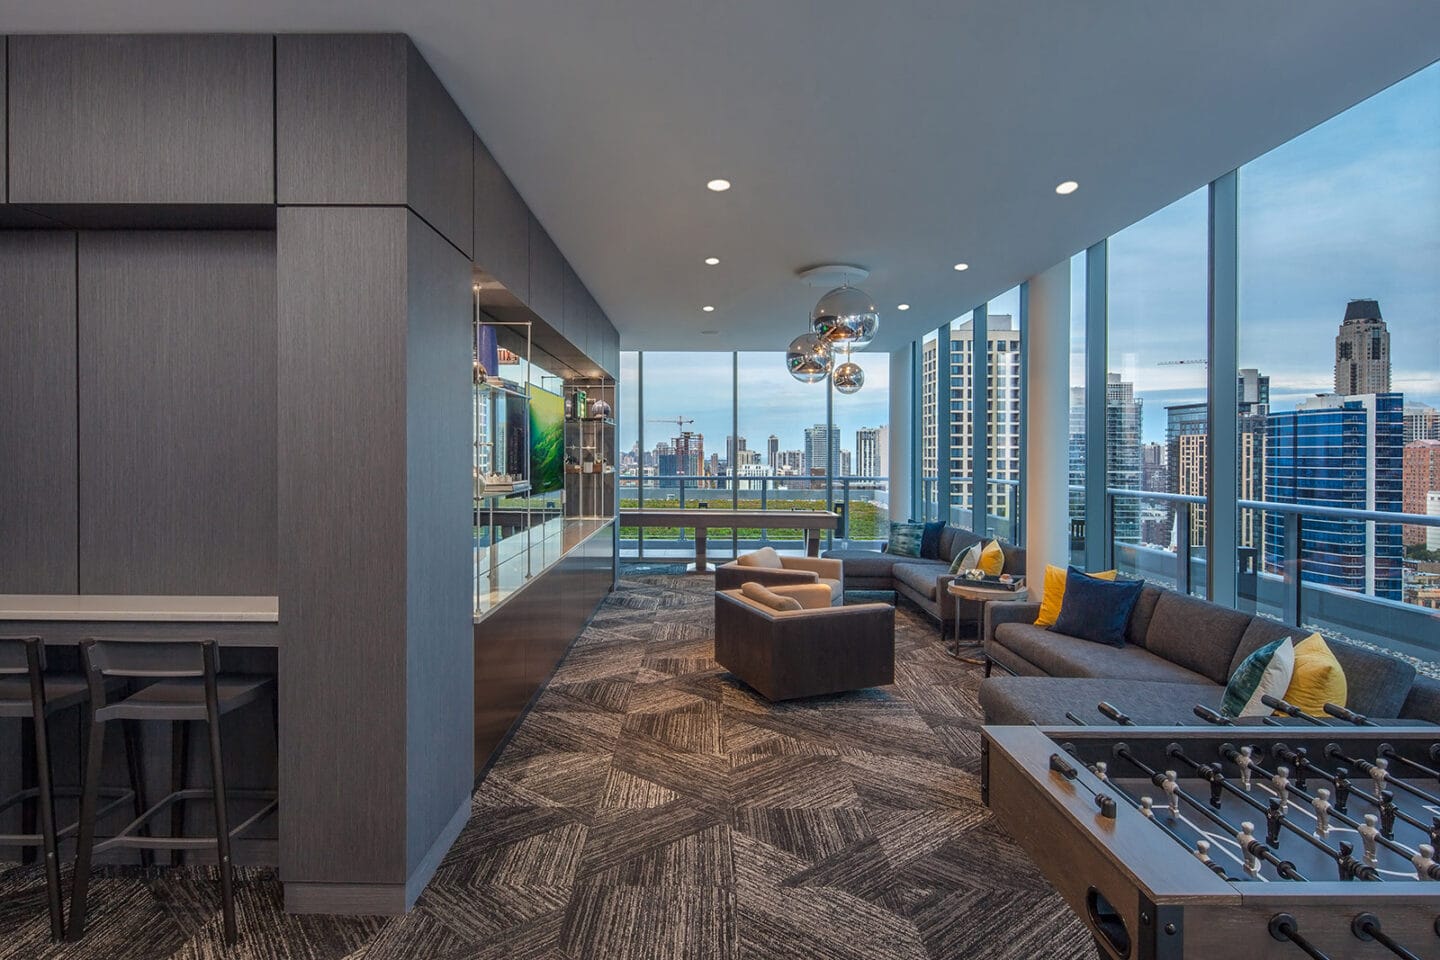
[1088,488,1440,664]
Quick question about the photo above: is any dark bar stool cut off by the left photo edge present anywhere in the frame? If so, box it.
[0,636,143,940]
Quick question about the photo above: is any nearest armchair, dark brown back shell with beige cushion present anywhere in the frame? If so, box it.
[716,583,896,701]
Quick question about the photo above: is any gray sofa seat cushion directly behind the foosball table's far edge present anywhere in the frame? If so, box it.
[979,676,1223,727]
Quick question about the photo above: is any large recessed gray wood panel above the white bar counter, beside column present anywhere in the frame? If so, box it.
[78,232,276,596]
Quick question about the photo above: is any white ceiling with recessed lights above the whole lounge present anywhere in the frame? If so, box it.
[0,0,1440,350]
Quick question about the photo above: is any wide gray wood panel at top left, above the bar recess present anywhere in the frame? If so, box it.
[9,35,275,203]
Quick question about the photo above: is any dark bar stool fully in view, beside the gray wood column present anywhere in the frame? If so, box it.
[69,639,278,943]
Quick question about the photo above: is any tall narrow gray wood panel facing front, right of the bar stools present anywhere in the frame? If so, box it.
[276,207,410,884]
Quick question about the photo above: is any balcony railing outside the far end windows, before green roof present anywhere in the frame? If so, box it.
[619,474,890,558]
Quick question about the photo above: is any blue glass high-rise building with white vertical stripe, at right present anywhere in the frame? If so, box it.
[1264,393,1404,600]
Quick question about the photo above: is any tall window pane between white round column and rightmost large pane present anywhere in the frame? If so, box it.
[1104,187,1210,593]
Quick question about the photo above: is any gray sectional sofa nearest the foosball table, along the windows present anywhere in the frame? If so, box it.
[979,581,1440,725]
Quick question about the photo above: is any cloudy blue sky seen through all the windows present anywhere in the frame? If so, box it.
[621,63,1440,455]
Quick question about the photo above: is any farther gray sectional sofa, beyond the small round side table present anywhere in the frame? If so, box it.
[824,525,1034,638]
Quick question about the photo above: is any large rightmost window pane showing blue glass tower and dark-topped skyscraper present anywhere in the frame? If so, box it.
[1236,56,1440,658]
